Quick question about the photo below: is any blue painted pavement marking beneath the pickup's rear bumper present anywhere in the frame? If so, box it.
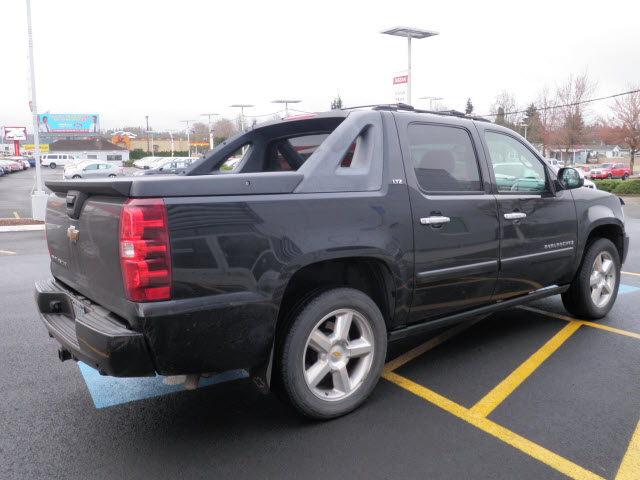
[78,362,249,408]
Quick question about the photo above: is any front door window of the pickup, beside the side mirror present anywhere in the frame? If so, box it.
[485,132,547,193]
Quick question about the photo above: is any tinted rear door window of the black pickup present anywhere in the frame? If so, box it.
[408,124,482,192]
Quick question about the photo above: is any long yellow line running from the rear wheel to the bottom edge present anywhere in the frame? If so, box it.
[382,370,608,480]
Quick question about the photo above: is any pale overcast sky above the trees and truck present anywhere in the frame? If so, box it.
[0,0,640,131]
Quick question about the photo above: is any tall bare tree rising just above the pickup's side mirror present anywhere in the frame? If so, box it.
[556,72,596,165]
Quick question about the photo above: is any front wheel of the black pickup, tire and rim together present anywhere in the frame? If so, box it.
[562,238,620,320]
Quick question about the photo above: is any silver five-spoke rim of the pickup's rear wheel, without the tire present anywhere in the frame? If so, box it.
[302,309,375,401]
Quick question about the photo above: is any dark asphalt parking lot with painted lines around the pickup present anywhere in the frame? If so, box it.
[0,169,640,480]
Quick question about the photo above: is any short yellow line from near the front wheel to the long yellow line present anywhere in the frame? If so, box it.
[470,321,581,417]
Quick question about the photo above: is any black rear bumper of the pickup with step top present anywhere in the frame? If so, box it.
[35,279,155,377]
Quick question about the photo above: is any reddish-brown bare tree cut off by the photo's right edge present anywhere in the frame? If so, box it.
[600,85,640,172]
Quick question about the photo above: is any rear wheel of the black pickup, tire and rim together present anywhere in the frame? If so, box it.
[277,288,387,420]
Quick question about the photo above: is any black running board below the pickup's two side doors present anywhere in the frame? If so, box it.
[389,285,569,342]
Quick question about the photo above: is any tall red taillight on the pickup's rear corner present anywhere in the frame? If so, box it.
[120,198,171,302]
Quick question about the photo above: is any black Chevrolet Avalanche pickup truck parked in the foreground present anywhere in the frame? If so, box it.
[36,105,628,418]
